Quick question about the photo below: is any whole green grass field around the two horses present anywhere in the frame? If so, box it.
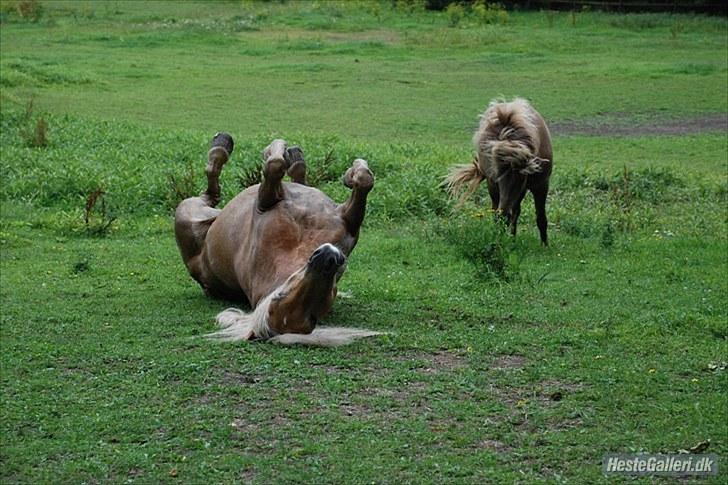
[0,0,728,484]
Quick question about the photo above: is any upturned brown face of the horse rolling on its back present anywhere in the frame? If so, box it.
[268,243,346,334]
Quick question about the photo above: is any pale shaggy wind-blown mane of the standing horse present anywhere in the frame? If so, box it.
[473,98,541,179]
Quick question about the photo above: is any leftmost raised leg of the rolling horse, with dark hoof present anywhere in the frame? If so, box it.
[174,133,234,287]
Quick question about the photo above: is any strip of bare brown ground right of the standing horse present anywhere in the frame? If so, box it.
[549,113,728,136]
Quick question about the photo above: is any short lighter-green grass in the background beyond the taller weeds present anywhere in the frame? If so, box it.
[0,1,728,146]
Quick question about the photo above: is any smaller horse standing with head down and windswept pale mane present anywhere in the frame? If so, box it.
[445,98,553,245]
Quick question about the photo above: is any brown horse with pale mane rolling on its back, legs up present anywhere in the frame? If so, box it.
[175,133,378,345]
